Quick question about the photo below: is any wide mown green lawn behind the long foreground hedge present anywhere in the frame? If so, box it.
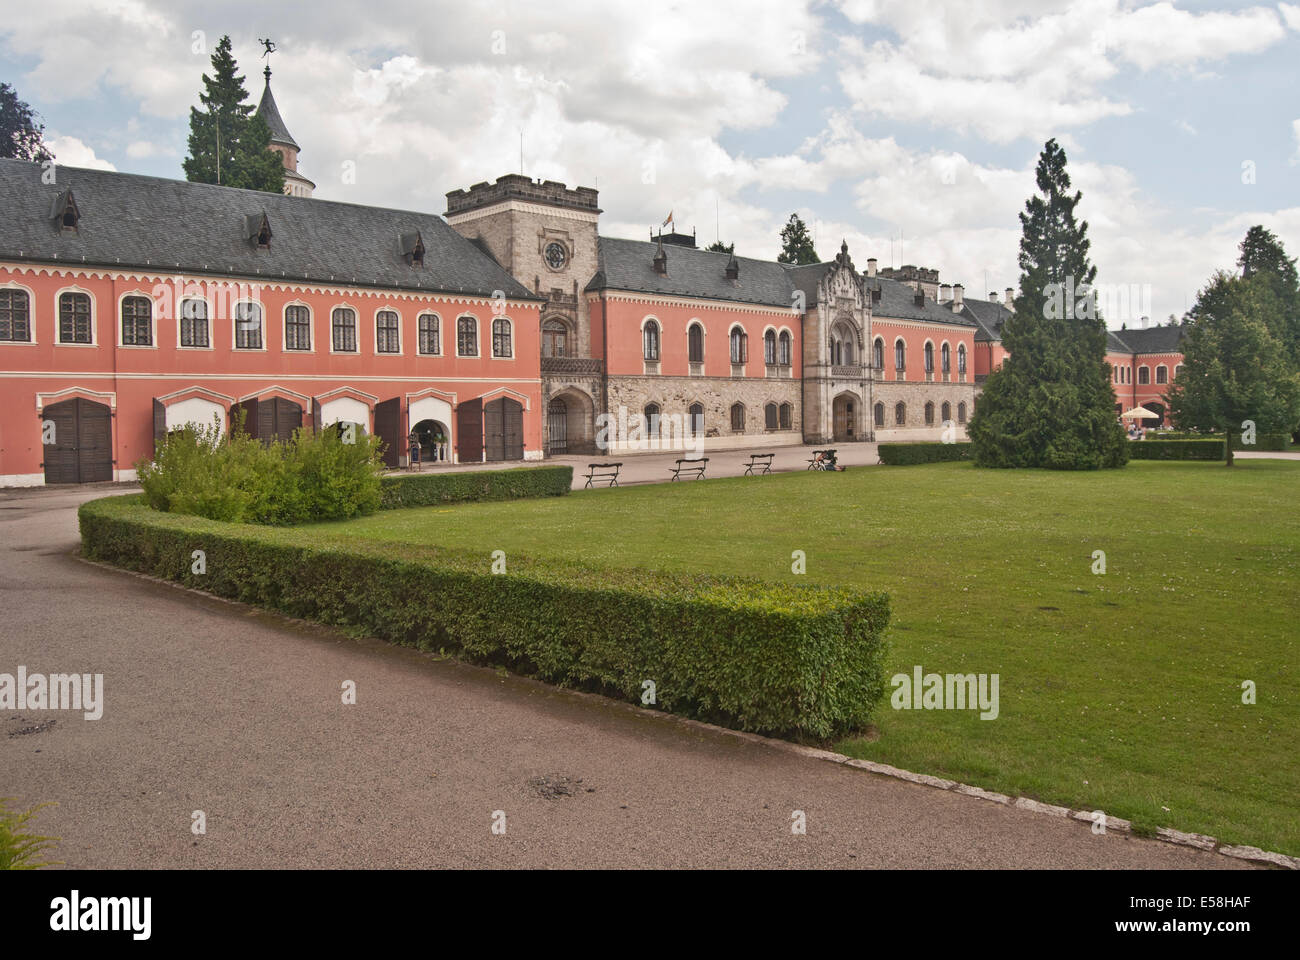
[301,460,1300,855]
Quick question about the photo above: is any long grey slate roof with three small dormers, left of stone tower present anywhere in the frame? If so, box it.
[0,160,541,300]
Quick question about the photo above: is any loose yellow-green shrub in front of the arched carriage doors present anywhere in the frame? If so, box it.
[135,423,384,526]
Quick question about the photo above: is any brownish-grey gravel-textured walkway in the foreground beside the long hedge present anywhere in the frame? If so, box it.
[0,488,1245,869]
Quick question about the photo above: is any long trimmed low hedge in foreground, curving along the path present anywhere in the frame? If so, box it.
[79,497,889,739]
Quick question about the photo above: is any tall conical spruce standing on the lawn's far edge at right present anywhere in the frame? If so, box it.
[970,139,1128,470]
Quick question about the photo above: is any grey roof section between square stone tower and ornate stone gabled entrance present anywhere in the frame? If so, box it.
[586,237,792,307]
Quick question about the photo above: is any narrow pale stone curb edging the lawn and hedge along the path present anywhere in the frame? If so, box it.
[83,552,1300,870]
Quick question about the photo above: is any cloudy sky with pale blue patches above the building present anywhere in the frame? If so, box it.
[0,0,1300,328]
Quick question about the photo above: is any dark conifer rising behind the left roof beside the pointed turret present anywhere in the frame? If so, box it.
[183,36,285,194]
